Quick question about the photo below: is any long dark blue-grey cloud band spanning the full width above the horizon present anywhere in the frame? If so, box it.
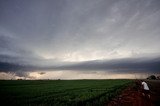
[0,57,160,75]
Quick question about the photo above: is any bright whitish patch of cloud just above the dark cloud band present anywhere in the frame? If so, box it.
[37,50,133,62]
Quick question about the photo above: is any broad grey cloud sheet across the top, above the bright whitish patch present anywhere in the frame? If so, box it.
[1,0,160,55]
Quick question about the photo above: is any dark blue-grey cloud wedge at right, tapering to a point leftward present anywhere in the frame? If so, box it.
[53,57,160,73]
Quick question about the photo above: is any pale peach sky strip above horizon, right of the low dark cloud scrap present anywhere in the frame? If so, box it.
[29,70,148,79]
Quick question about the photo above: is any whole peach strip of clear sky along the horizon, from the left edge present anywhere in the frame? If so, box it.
[0,70,149,80]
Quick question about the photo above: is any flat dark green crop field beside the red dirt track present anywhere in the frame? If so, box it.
[0,80,132,106]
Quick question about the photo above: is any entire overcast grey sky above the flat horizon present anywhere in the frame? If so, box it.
[0,0,160,79]
